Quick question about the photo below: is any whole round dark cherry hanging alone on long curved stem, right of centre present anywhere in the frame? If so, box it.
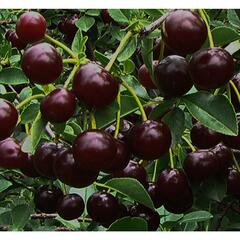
[128,120,172,160]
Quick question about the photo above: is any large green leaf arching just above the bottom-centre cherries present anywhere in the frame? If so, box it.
[104,178,154,209]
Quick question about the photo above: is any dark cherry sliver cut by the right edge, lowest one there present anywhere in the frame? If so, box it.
[227,168,240,200]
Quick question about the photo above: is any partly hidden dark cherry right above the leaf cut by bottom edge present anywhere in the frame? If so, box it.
[130,205,160,231]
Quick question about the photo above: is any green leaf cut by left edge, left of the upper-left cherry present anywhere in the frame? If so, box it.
[0,67,29,85]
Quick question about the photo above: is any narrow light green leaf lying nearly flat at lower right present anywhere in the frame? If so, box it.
[179,211,213,224]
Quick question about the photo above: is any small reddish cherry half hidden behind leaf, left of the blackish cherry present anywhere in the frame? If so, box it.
[138,61,158,89]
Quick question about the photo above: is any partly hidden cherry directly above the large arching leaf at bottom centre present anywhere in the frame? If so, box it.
[114,160,147,186]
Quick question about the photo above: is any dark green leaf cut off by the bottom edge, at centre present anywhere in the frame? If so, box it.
[107,217,148,231]
